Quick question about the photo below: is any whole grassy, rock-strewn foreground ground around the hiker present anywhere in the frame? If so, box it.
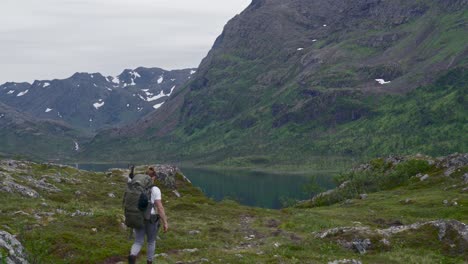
[0,154,468,263]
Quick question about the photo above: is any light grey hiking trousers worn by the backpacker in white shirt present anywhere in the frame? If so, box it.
[130,220,159,261]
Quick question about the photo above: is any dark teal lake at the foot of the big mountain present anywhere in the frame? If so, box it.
[76,164,334,209]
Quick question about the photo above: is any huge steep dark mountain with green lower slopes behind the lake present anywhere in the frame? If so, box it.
[82,0,468,165]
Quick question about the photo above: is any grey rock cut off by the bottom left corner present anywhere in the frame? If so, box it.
[0,230,28,264]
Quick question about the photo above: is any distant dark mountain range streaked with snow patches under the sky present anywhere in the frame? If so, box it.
[0,67,195,131]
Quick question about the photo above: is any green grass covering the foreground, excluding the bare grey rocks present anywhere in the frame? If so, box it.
[0,158,468,263]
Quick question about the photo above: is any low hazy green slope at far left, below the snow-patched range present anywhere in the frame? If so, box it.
[0,103,82,160]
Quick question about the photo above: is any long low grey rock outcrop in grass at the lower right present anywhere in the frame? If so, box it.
[313,220,468,254]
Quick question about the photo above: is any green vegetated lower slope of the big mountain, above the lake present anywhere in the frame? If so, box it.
[83,65,468,169]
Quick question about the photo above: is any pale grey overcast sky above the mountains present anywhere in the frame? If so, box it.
[0,0,251,83]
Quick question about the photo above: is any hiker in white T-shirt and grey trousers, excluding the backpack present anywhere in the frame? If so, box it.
[128,167,169,264]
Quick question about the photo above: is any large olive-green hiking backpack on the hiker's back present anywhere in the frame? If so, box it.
[123,174,154,228]
